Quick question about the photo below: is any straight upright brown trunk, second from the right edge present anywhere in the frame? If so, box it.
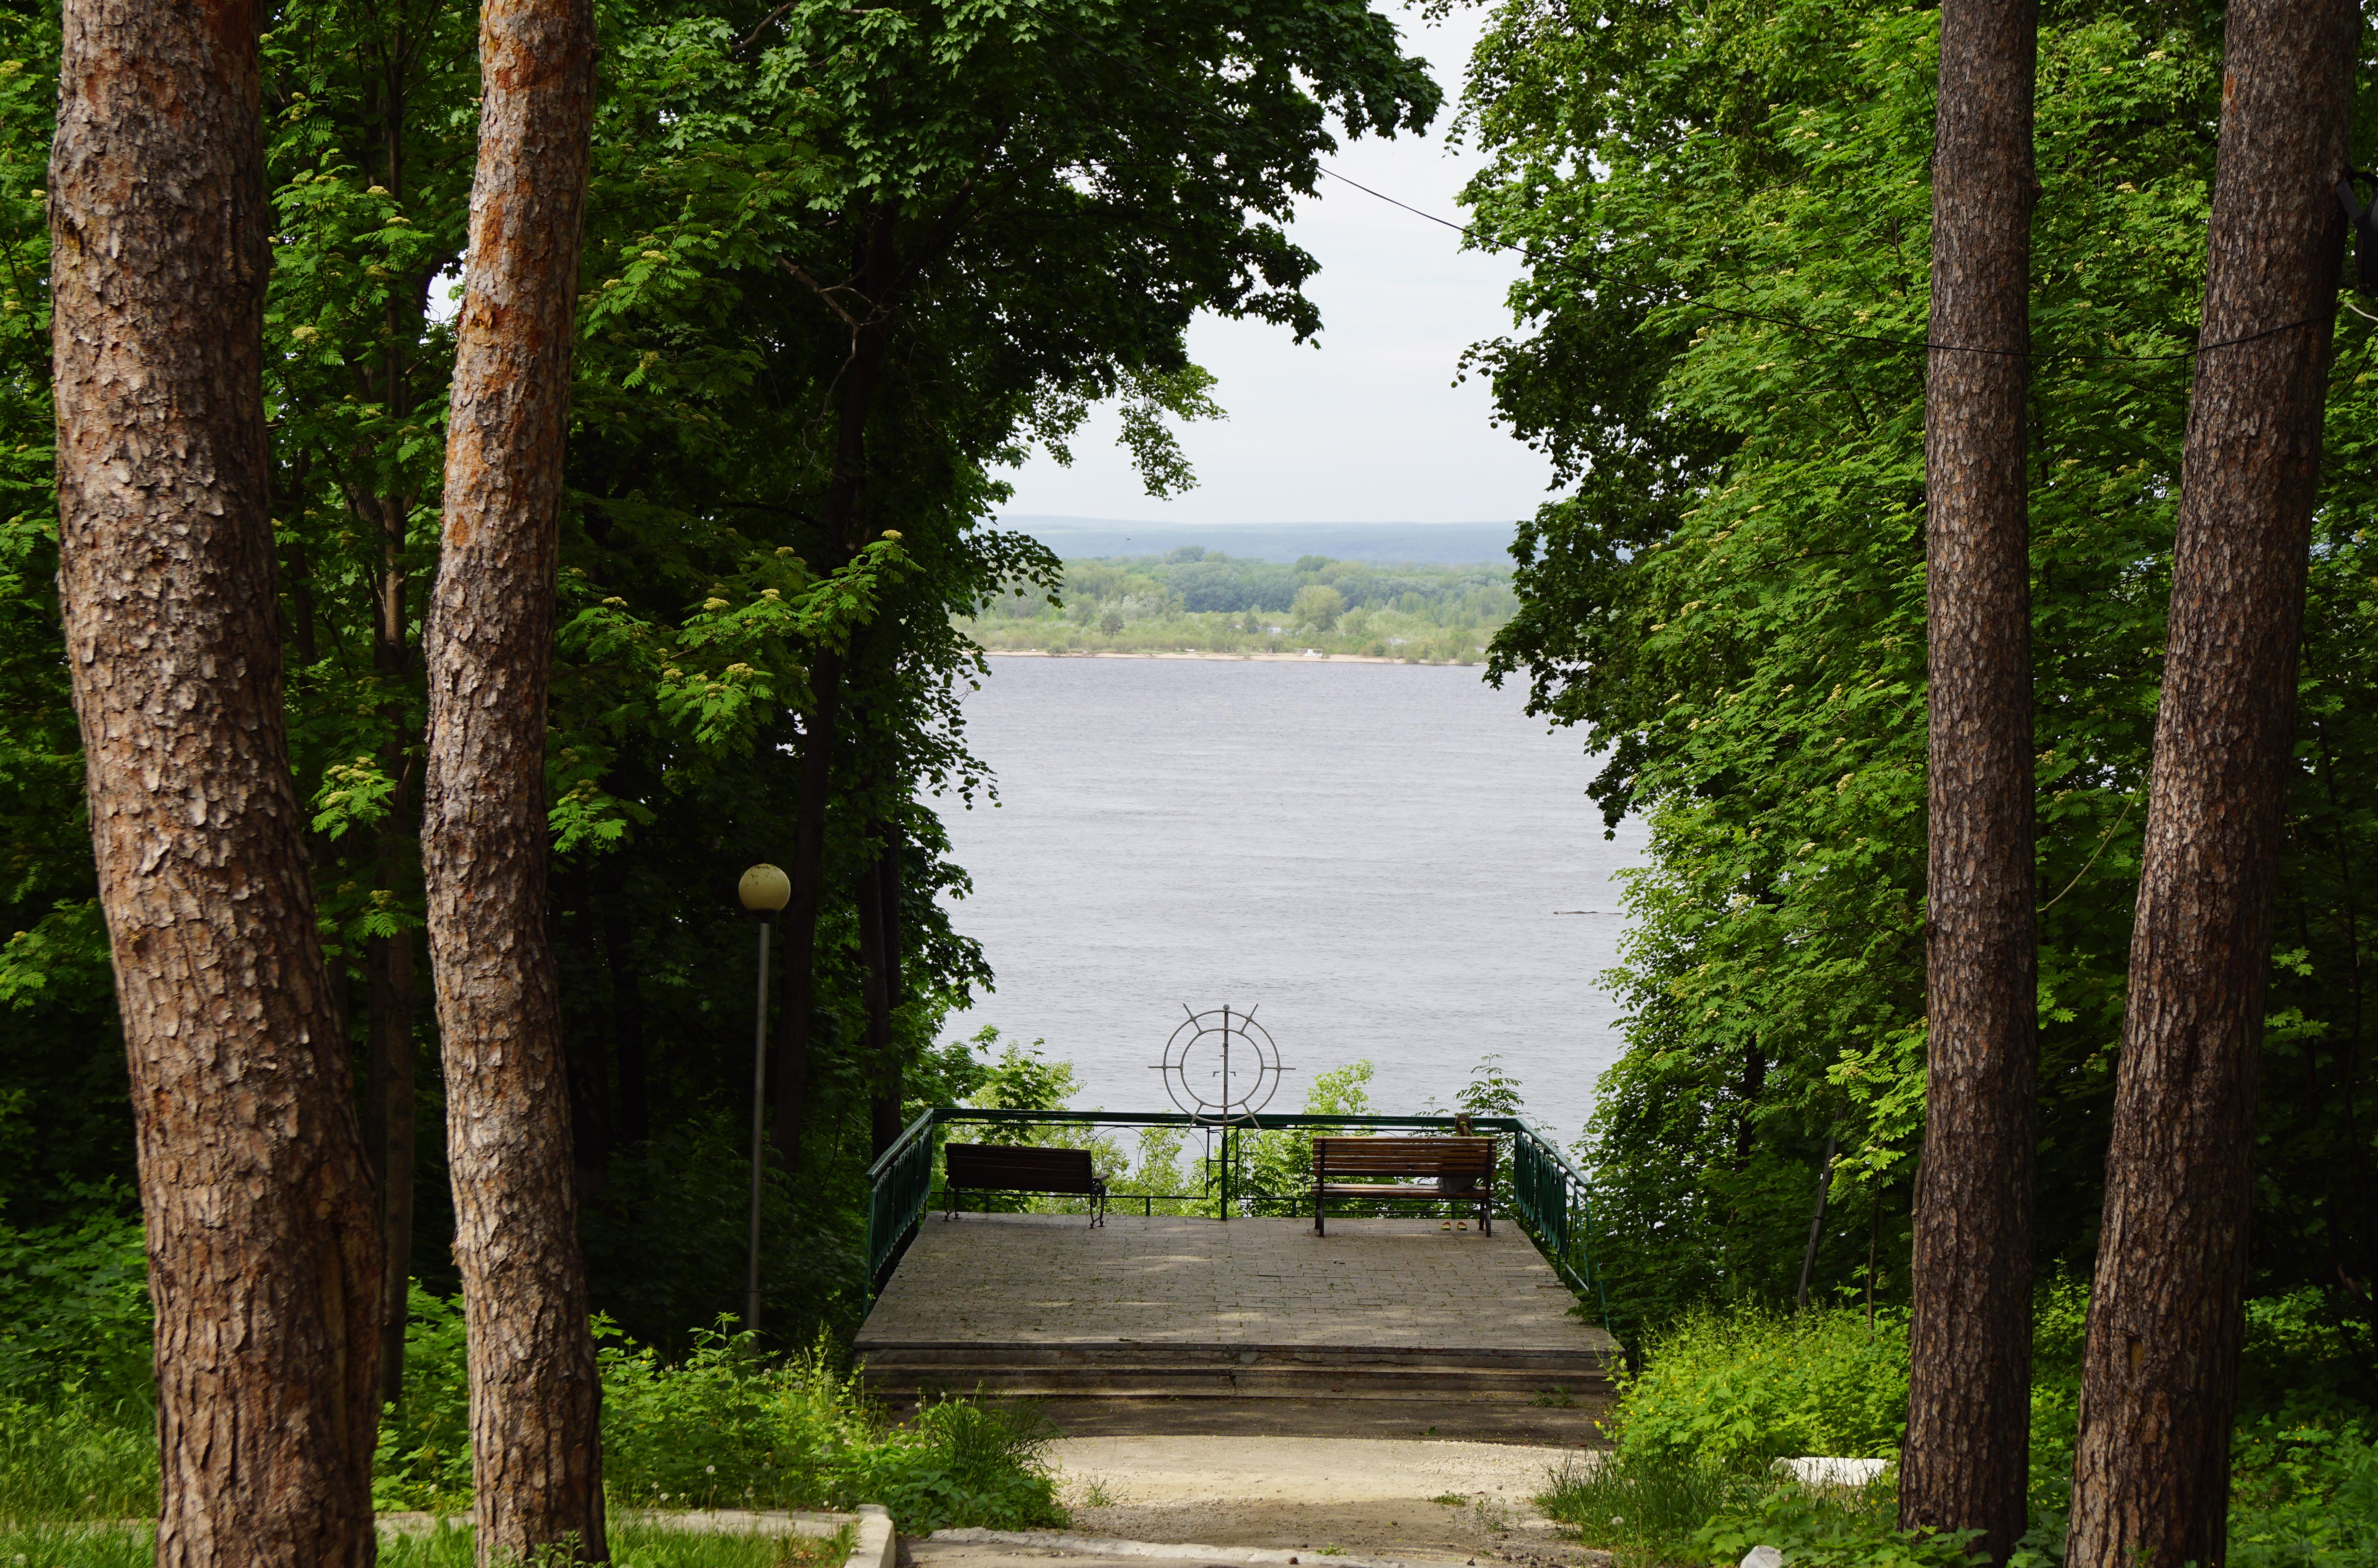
[1900,0,2038,1561]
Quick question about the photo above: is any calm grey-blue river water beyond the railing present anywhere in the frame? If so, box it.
[942,658,1643,1140]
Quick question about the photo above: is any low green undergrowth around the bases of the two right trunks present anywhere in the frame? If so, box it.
[1536,1278,2378,1568]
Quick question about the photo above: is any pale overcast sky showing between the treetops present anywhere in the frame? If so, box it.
[1006,5,1548,523]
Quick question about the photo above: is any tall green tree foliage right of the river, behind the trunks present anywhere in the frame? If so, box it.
[1465,0,2378,1349]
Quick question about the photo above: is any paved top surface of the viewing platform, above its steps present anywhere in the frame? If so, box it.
[858,1214,1615,1354]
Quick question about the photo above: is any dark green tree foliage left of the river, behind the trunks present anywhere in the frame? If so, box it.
[0,0,1436,1368]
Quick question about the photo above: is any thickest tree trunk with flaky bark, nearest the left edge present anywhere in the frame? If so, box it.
[50,0,380,1568]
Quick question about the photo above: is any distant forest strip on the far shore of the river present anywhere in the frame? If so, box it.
[958,544,1517,663]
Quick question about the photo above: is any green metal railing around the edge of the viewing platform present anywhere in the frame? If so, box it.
[866,1105,1610,1328]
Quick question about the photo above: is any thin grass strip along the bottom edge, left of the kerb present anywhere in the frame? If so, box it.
[0,1518,849,1568]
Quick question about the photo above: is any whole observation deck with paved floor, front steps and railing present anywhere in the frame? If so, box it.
[856,1112,1617,1447]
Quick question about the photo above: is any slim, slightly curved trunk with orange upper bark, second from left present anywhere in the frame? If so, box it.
[421,0,606,1563]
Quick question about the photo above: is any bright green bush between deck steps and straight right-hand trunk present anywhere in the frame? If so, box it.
[1617,1307,1907,1471]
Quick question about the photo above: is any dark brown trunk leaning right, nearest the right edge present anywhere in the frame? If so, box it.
[2066,0,2361,1568]
